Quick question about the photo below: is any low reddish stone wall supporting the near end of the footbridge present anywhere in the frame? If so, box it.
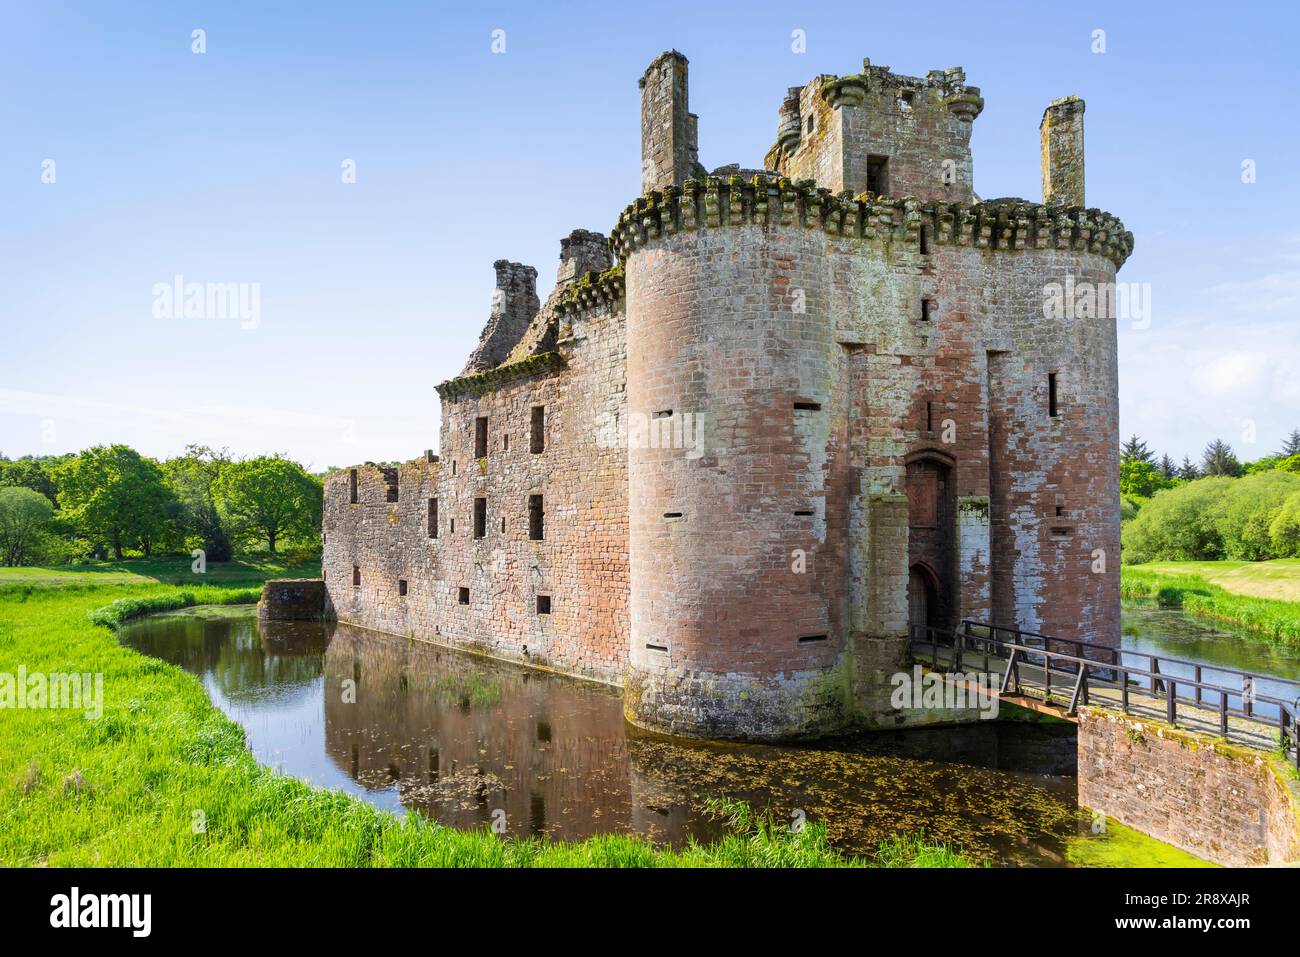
[1079,707,1300,867]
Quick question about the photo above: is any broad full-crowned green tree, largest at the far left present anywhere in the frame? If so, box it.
[57,445,176,560]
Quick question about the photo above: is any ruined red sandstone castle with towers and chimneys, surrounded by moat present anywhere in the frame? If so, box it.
[324,51,1132,740]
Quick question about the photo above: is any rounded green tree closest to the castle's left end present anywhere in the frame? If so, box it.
[213,455,321,554]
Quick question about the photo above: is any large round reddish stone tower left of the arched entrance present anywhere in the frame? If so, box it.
[625,225,848,739]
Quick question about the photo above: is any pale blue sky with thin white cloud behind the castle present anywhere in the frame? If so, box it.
[0,1,1300,468]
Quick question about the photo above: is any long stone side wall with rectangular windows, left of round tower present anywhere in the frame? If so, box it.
[324,280,628,681]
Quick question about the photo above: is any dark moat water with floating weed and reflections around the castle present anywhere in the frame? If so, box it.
[121,607,1300,866]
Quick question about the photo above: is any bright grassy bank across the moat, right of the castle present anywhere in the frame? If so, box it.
[1121,563,1300,646]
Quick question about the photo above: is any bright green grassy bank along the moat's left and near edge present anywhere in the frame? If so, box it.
[0,568,967,867]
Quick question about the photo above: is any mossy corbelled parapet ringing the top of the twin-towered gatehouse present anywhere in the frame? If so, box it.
[610,176,1134,268]
